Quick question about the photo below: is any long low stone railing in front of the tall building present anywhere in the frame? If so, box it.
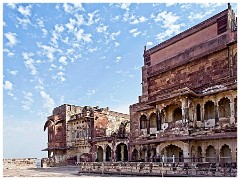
[76,162,237,177]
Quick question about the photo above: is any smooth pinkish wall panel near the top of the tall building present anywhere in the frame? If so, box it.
[150,23,217,66]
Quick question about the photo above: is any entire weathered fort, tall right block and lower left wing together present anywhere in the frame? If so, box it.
[43,4,237,165]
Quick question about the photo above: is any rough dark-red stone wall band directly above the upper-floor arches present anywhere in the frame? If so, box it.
[148,45,237,101]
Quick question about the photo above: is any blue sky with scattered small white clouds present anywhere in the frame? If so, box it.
[2,2,237,158]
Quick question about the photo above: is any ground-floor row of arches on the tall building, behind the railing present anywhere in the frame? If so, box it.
[131,144,234,163]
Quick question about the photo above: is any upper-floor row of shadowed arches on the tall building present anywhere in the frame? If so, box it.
[140,97,237,130]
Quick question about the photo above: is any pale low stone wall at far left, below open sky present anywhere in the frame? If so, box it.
[3,158,37,169]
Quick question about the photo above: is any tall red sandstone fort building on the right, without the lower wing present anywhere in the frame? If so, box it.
[128,4,237,162]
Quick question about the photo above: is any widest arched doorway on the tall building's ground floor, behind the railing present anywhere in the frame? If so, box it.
[161,144,184,162]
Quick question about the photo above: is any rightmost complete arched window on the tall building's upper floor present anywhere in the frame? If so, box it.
[218,97,230,118]
